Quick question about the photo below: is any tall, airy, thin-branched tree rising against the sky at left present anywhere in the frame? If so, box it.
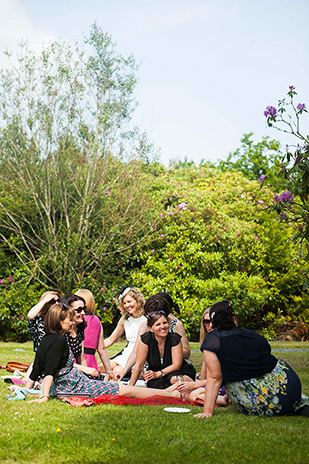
[0,25,156,292]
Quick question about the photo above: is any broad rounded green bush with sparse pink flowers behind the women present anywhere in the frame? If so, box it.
[131,166,309,340]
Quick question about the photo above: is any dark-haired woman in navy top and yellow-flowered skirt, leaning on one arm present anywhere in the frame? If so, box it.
[195,300,309,418]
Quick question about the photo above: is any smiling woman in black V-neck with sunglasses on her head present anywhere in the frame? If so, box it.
[130,297,196,389]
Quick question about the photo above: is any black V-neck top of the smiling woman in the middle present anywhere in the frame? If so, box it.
[141,332,181,371]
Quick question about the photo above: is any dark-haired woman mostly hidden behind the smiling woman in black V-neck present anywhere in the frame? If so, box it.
[116,292,191,380]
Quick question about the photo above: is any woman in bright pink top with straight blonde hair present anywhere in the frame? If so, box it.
[75,289,113,379]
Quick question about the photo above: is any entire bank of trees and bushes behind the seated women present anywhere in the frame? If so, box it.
[0,25,309,341]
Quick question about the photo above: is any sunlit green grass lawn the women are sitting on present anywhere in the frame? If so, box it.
[0,342,309,464]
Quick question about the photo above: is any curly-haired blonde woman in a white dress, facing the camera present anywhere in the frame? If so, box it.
[104,287,147,378]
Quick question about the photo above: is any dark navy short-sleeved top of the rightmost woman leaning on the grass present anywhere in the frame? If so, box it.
[201,327,277,385]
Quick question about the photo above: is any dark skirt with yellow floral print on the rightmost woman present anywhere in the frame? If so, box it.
[225,359,308,416]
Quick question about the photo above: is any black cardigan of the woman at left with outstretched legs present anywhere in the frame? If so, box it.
[30,334,69,380]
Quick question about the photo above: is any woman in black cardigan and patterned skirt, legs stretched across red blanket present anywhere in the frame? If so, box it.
[26,303,180,403]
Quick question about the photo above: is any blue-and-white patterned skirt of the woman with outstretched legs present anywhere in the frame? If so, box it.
[50,352,119,398]
